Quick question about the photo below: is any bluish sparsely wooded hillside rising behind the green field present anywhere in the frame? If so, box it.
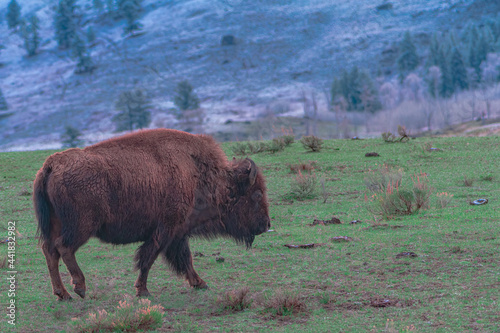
[0,0,499,150]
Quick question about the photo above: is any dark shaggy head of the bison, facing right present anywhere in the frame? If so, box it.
[225,158,271,247]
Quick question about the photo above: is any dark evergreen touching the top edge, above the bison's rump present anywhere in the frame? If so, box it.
[55,0,78,49]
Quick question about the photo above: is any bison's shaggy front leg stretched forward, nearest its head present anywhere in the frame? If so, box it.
[163,237,208,289]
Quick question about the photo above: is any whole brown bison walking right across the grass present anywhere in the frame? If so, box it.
[33,129,270,300]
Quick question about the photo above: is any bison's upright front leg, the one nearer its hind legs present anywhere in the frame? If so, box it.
[134,240,160,297]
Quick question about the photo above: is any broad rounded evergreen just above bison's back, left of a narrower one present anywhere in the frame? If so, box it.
[112,89,151,132]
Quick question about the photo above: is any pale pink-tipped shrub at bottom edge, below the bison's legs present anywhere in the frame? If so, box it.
[73,295,165,332]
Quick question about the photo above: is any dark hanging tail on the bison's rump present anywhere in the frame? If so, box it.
[33,166,52,242]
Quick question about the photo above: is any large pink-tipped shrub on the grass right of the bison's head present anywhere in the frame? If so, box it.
[365,173,431,219]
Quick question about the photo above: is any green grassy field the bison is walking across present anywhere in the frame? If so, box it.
[0,136,500,332]
